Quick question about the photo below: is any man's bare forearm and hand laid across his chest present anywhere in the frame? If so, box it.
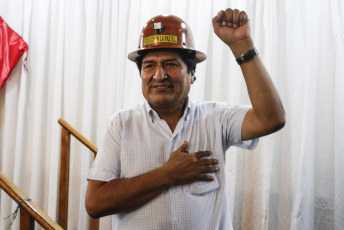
[85,141,219,218]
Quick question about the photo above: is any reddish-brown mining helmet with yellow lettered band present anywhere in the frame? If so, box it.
[128,15,207,63]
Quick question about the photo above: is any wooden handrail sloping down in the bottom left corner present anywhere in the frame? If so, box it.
[0,172,62,230]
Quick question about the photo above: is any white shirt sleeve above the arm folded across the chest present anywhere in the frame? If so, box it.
[87,117,122,182]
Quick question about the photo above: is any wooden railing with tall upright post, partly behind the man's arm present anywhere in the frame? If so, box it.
[57,119,99,230]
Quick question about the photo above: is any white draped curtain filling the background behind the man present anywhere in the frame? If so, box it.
[0,0,344,230]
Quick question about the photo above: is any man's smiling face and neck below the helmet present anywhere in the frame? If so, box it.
[141,51,195,132]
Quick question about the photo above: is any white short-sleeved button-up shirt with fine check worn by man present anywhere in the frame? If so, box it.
[88,100,258,230]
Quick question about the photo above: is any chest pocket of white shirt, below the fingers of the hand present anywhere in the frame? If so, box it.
[189,174,219,196]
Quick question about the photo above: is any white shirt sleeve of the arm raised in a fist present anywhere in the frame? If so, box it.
[221,104,259,150]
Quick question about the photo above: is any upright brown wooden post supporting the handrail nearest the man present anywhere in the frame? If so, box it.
[57,128,70,230]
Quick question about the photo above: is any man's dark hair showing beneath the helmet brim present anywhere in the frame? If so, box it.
[135,48,197,75]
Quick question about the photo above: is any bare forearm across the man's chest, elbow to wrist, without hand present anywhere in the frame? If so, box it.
[86,168,170,218]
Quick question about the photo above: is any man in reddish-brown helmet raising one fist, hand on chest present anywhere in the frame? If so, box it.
[86,9,285,230]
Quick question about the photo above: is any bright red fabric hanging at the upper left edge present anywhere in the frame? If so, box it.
[0,17,29,89]
